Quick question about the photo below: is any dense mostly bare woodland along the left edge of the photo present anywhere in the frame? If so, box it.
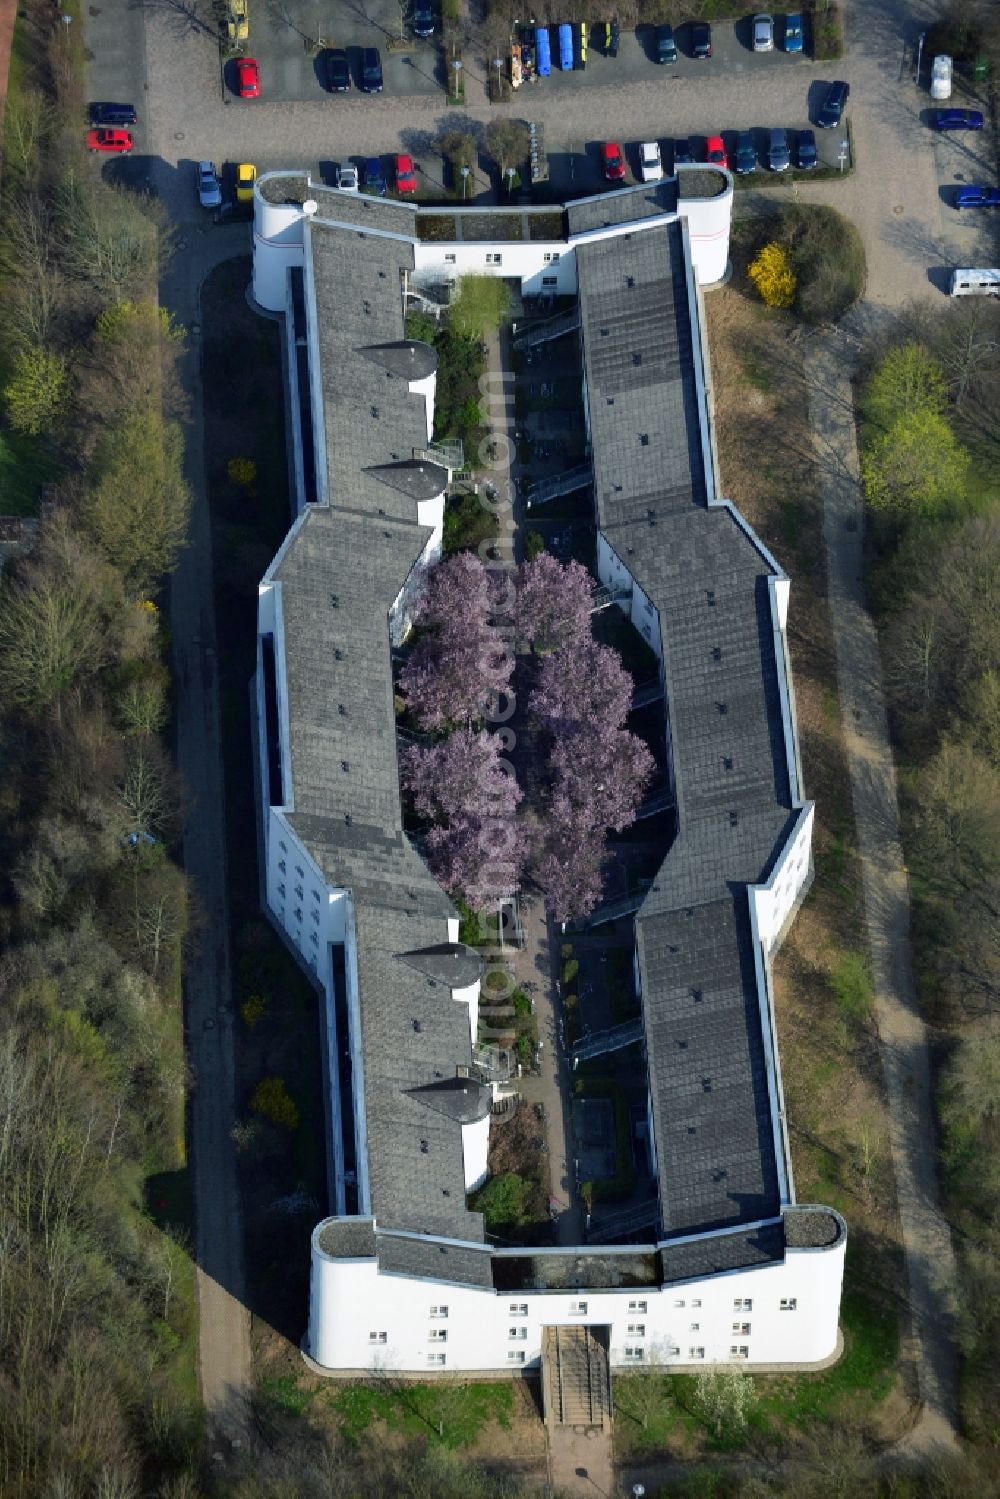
[0,6,201,1499]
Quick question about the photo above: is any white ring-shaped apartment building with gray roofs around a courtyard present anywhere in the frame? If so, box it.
[253,168,846,1373]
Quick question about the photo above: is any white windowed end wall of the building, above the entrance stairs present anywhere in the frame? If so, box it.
[306,1225,846,1373]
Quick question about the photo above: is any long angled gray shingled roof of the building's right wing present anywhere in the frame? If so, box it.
[577,225,792,1243]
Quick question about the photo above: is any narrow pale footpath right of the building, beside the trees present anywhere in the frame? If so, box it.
[807,336,958,1456]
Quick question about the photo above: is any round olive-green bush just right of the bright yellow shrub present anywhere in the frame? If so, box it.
[778,204,867,324]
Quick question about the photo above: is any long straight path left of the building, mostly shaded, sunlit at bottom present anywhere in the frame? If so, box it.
[160,225,257,1456]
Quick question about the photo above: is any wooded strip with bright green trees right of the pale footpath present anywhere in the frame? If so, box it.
[859,303,1000,1445]
